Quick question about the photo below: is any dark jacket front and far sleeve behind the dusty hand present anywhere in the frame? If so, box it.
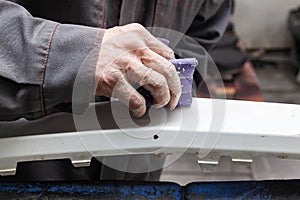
[14,0,232,49]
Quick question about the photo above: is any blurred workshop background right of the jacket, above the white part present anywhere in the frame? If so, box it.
[198,0,300,104]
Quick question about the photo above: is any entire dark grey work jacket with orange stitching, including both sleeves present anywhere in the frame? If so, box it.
[0,0,231,120]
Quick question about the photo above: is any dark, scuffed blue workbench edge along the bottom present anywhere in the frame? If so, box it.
[0,180,300,200]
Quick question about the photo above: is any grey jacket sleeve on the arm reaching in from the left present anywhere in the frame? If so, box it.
[0,0,104,121]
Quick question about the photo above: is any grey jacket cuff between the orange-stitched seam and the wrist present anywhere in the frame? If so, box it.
[42,24,104,115]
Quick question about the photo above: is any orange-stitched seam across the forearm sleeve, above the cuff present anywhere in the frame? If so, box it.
[40,23,59,117]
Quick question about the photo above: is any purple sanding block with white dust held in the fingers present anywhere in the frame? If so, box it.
[137,58,198,107]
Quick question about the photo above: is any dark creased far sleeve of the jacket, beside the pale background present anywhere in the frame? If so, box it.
[186,0,232,51]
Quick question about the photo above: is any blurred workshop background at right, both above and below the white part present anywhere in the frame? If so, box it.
[161,0,300,184]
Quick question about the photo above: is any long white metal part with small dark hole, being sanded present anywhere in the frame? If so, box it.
[0,99,300,175]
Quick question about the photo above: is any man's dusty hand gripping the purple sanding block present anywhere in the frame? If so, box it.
[96,24,181,117]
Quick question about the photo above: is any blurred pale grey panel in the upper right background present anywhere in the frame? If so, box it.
[233,0,300,49]
